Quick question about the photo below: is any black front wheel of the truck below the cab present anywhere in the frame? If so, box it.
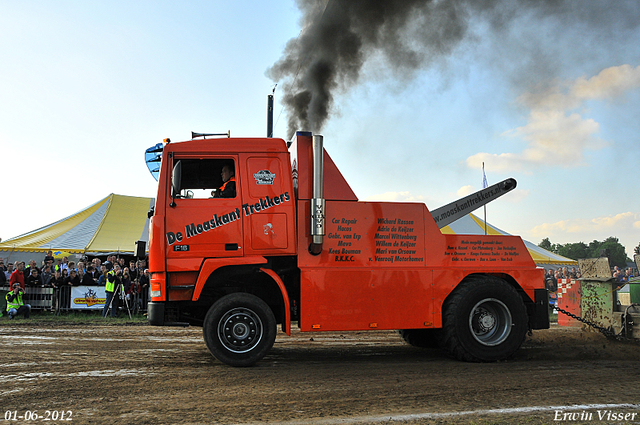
[202,293,277,367]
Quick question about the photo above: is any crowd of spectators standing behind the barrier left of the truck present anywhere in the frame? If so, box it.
[0,251,150,314]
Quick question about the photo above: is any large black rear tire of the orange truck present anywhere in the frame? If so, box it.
[441,277,528,362]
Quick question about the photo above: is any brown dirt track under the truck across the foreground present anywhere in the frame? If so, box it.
[0,319,640,424]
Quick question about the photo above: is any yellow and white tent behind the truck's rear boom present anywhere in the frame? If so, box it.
[440,214,578,267]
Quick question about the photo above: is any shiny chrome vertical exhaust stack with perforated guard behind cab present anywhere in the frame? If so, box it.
[309,135,325,255]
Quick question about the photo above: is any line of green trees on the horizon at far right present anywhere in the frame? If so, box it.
[538,236,640,267]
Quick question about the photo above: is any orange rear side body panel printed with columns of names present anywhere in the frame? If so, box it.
[298,201,542,331]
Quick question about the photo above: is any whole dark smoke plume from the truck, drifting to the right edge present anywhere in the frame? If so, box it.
[267,0,639,137]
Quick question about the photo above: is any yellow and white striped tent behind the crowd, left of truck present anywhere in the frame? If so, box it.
[0,193,155,257]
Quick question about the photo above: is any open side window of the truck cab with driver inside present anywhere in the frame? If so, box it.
[176,158,236,199]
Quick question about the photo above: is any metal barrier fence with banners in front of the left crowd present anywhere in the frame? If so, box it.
[0,286,149,314]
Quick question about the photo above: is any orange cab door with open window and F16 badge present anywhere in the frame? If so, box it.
[165,153,243,260]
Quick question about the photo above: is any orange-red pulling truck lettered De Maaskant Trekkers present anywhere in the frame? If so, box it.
[148,132,549,366]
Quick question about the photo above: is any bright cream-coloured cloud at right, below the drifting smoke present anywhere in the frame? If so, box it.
[466,65,640,171]
